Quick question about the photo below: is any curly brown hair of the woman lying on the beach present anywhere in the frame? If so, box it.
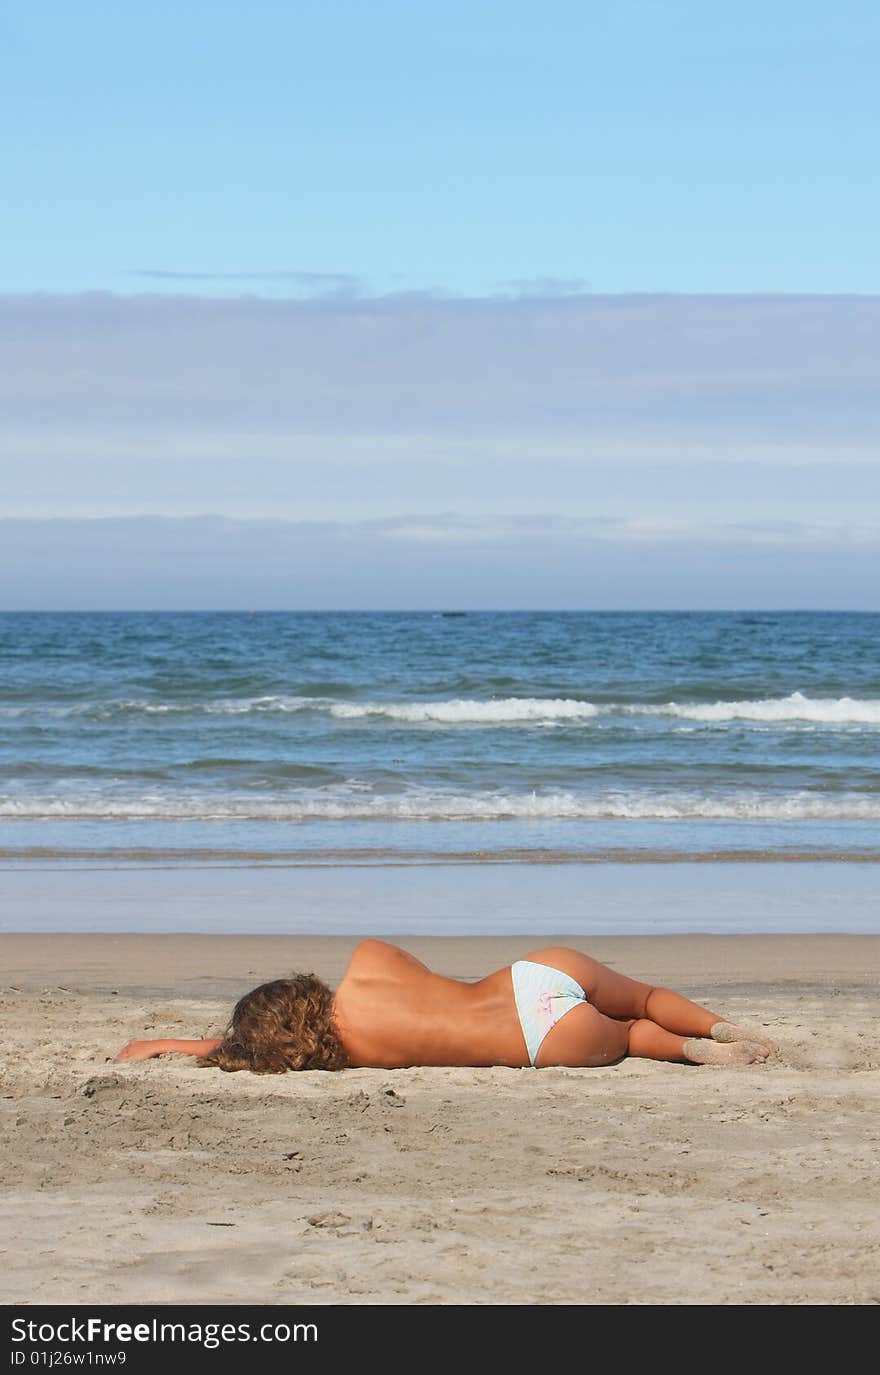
[198,974,348,1074]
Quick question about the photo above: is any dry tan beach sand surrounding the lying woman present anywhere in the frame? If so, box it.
[0,935,880,1305]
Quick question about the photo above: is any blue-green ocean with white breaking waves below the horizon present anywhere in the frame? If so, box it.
[0,608,880,865]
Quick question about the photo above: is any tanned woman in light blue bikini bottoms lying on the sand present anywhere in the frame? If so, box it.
[117,941,776,1074]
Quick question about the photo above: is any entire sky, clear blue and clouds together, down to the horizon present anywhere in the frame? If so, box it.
[0,0,880,608]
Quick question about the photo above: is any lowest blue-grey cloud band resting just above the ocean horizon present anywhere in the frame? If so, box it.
[0,513,880,611]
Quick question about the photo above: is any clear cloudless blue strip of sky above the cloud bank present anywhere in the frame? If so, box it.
[6,0,880,294]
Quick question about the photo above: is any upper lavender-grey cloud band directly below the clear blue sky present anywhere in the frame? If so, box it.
[0,293,880,440]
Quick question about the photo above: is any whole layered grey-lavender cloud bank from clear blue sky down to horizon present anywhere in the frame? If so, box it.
[0,290,880,605]
